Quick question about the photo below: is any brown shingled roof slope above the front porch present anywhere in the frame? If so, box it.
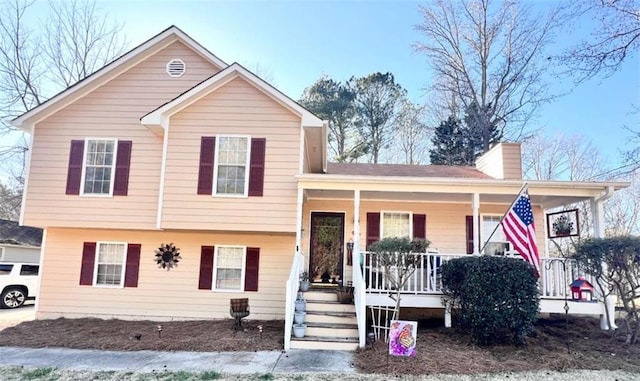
[327,163,492,179]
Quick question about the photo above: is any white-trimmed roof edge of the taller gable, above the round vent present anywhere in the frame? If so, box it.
[11,25,228,131]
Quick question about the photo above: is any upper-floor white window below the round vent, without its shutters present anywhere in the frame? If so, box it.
[82,139,117,196]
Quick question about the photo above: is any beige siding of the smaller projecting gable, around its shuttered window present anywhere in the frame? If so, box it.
[162,78,300,232]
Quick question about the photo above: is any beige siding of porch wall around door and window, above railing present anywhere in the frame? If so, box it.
[302,199,545,256]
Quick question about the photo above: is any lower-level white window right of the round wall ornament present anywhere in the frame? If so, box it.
[213,246,247,291]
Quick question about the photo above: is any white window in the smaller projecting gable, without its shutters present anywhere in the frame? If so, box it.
[214,136,251,196]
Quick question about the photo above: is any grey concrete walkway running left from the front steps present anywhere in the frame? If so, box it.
[0,347,356,374]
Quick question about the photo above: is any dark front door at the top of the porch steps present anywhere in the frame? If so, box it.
[309,212,344,283]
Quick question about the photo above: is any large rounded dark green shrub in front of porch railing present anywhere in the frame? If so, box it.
[442,256,540,345]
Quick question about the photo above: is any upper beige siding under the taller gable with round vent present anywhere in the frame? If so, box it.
[24,42,217,228]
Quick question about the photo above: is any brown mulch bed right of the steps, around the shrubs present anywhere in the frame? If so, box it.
[356,317,640,375]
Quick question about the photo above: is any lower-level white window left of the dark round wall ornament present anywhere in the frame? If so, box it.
[93,242,127,286]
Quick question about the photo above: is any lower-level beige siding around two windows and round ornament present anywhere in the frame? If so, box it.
[37,229,295,320]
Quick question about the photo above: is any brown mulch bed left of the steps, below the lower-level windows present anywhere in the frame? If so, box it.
[0,318,284,352]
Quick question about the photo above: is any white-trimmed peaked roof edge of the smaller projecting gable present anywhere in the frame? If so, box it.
[140,62,324,128]
